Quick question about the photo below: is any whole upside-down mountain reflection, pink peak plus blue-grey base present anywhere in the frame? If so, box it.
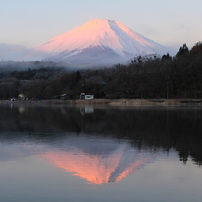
[41,135,155,184]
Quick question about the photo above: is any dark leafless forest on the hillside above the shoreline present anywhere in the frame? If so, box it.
[0,42,202,99]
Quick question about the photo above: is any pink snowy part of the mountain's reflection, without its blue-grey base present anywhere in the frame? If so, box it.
[41,141,154,184]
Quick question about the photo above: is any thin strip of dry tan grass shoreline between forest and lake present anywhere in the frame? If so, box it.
[0,99,202,107]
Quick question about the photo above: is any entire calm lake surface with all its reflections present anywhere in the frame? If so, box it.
[0,105,202,202]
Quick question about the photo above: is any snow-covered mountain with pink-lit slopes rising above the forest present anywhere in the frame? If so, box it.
[34,20,168,63]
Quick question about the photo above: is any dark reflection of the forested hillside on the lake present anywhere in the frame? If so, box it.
[0,105,202,165]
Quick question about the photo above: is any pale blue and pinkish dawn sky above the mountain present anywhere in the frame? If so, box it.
[0,0,202,48]
